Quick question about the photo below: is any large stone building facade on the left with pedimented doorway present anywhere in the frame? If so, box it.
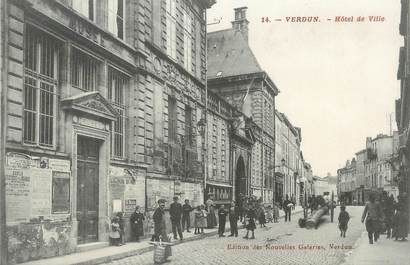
[2,0,215,263]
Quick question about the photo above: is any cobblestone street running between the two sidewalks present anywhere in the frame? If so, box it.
[102,206,364,265]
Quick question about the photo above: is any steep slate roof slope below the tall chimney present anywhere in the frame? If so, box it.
[208,29,263,79]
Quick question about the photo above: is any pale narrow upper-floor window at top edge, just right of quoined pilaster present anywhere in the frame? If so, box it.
[166,0,177,59]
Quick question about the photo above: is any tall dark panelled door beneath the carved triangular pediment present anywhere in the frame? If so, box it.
[77,136,100,244]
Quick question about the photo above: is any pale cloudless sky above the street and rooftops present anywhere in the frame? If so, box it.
[207,0,403,177]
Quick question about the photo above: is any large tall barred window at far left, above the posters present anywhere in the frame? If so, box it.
[23,26,59,147]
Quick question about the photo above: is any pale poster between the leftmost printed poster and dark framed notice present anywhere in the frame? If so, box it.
[30,168,52,217]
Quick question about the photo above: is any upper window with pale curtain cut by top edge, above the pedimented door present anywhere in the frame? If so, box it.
[108,0,125,40]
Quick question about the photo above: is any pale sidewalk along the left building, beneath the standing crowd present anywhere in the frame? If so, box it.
[20,206,303,265]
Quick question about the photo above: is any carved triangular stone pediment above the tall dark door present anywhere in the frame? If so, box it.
[61,91,118,121]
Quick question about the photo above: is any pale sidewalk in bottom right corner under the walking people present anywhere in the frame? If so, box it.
[343,231,410,265]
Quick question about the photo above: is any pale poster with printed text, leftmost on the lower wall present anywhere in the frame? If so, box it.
[5,167,31,222]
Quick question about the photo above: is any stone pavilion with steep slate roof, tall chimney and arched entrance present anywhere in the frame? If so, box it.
[207,7,278,203]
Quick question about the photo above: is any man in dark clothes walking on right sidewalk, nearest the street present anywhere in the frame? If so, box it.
[362,194,381,244]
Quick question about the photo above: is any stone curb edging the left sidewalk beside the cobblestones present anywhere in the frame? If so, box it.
[70,209,303,265]
